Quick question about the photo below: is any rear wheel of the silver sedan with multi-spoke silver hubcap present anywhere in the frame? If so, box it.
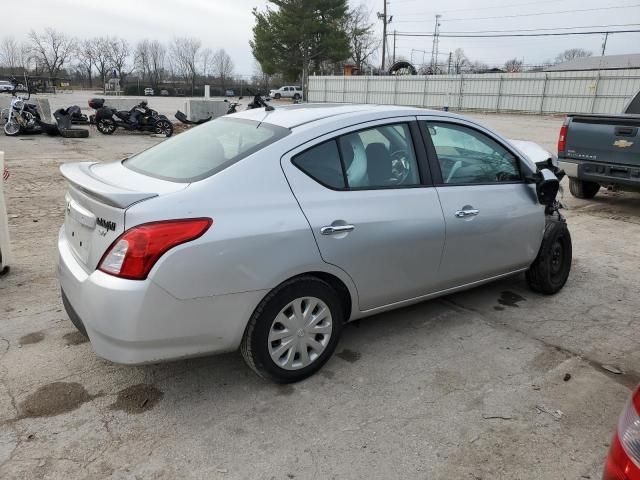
[240,276,344,383]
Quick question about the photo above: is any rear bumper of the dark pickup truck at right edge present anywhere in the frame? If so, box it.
[558,159,640,188]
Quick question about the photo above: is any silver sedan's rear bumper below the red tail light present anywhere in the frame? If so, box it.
[58,230,267,364]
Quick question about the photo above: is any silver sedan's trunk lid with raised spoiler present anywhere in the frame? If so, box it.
[60,162,189,271]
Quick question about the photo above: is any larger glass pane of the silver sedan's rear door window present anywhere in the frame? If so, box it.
[338,123,420,188]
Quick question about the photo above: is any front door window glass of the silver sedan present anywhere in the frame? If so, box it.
[425,122,522,184]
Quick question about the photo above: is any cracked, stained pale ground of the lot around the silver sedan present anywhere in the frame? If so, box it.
[0,100,640,480]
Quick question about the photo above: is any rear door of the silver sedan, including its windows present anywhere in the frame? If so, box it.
[282,118,444,310]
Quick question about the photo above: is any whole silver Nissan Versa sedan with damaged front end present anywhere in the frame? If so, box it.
[58,104,571,382]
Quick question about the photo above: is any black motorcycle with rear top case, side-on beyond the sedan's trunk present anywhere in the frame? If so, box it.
[89,98,173,137]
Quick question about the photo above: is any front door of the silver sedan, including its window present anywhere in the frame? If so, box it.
[420,118,544,287]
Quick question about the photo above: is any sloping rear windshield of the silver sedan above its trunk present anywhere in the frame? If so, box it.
[124,117,290,183]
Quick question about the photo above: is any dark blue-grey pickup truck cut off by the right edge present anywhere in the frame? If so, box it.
[558,88,640,198]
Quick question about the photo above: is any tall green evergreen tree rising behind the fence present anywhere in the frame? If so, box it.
[249,0,351,81]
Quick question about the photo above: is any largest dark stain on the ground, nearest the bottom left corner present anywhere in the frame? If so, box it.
[20,382,94,418]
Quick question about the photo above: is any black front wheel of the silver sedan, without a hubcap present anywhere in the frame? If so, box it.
[526,217,573,295]
